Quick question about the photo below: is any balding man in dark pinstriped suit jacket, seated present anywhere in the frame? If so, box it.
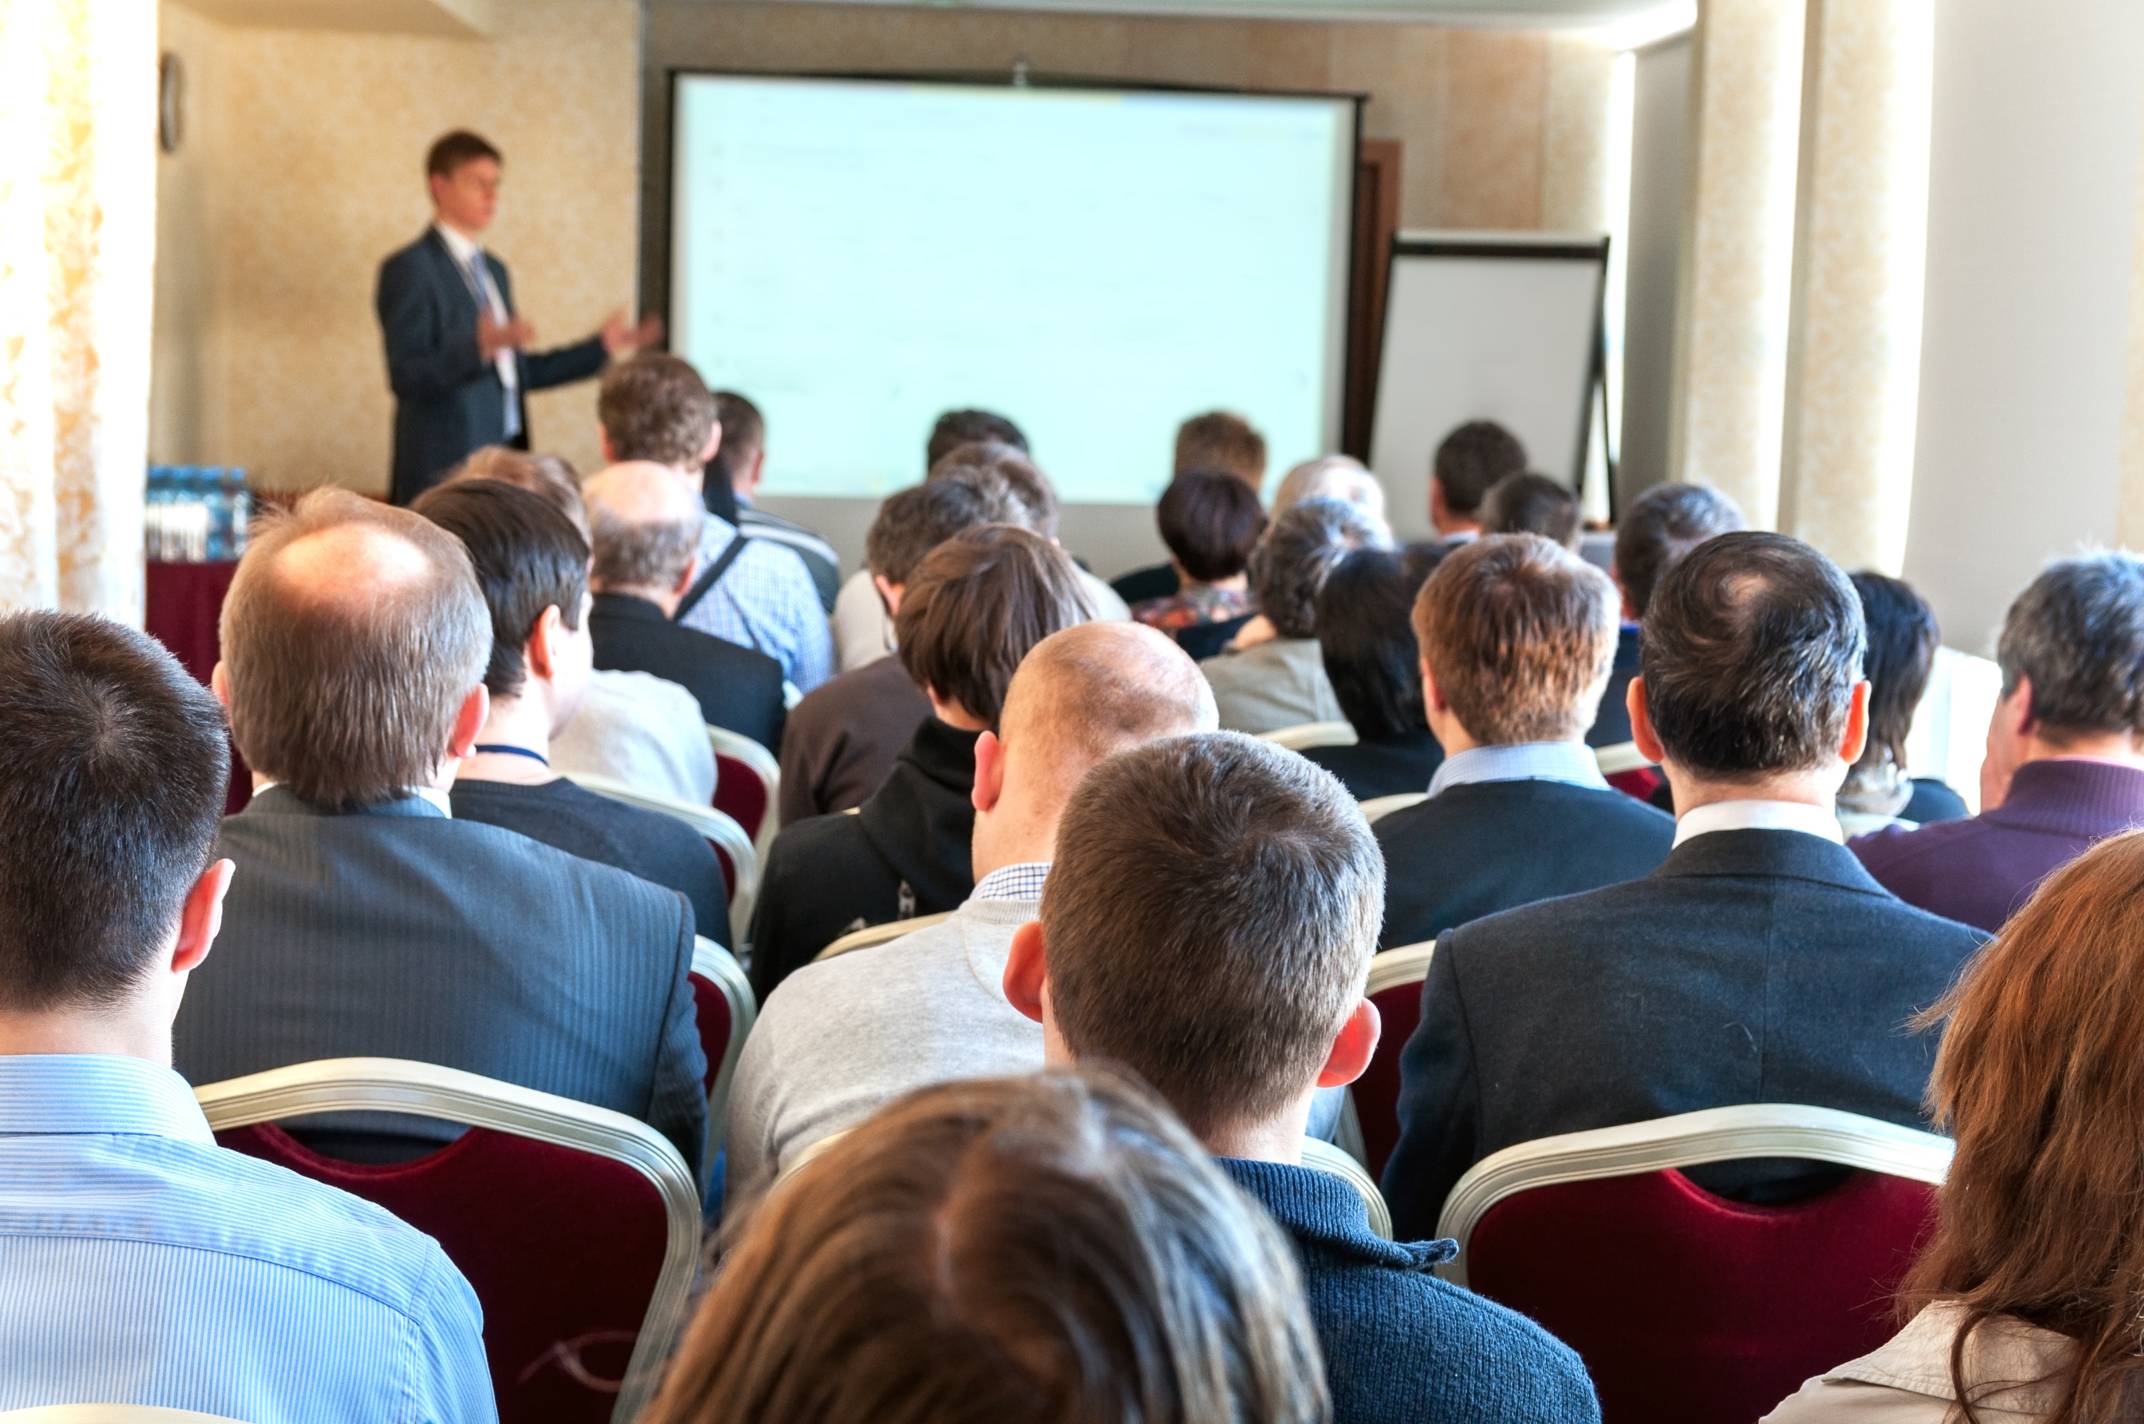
[174,489,708,1165]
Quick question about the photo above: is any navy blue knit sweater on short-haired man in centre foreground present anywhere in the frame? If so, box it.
[1220,1158,1602,1424]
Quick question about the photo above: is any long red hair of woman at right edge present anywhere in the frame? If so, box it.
[1900,830,2144,1424]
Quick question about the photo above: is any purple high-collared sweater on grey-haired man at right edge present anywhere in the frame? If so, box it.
[1848,761,2144,933]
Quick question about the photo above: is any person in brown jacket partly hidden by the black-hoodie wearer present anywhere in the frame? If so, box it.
[783,470,1027,826]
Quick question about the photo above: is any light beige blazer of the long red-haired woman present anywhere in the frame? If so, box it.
[1760,1306,2118,1424]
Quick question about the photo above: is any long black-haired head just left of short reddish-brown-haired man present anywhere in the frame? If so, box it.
[1319,549,1428,740]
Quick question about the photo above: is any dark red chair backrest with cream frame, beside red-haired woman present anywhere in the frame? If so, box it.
[1439,1102,1951,1424]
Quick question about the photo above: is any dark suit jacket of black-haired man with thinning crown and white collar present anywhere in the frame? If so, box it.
[1385,830,1981,1240]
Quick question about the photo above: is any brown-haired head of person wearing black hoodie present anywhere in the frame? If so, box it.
[894,523,1093,727]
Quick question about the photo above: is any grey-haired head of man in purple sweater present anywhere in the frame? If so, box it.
[1996,553,2144,746]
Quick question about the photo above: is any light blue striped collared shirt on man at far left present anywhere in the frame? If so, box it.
[0,1055,497,1424]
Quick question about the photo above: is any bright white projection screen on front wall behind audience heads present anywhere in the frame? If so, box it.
[671,75,1355,504]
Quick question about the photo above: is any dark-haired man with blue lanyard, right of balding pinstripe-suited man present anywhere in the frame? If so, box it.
[410,480,729,944]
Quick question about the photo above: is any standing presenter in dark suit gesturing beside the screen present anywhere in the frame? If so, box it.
[373,129,662,504]
